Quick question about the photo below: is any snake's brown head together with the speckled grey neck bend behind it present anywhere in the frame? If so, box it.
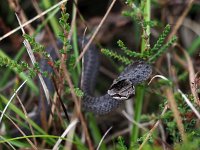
[107,61,152,100]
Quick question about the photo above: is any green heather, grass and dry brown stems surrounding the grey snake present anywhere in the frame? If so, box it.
[0,0,200,150]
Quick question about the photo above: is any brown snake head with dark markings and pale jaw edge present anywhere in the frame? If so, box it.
[108,79,135,100]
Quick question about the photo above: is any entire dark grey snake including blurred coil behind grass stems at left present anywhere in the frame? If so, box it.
[8,40,152,136]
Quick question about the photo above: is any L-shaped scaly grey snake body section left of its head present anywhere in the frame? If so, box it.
[82,41,121,115]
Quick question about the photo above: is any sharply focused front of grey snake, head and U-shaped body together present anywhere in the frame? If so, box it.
[82,41,152,115]
